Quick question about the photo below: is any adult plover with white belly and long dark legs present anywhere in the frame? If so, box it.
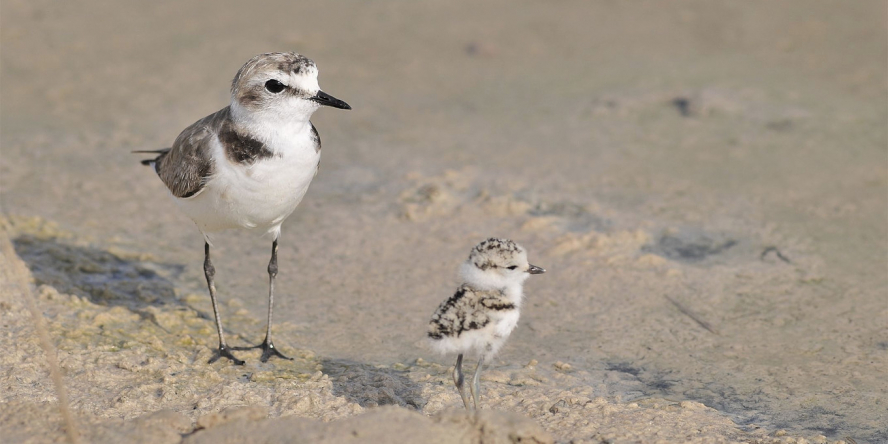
[138,52,351,365]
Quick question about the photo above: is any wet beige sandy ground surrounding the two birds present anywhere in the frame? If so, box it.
[0,1,888,443]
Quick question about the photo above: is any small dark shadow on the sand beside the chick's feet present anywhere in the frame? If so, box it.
[321,359,426,411]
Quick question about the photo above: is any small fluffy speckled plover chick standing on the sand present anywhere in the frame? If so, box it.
[428,238,546,410]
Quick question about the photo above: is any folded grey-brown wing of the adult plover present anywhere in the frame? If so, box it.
[154,107,230,198]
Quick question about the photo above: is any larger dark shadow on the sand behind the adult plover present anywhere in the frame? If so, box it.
[13,235,185,313]
